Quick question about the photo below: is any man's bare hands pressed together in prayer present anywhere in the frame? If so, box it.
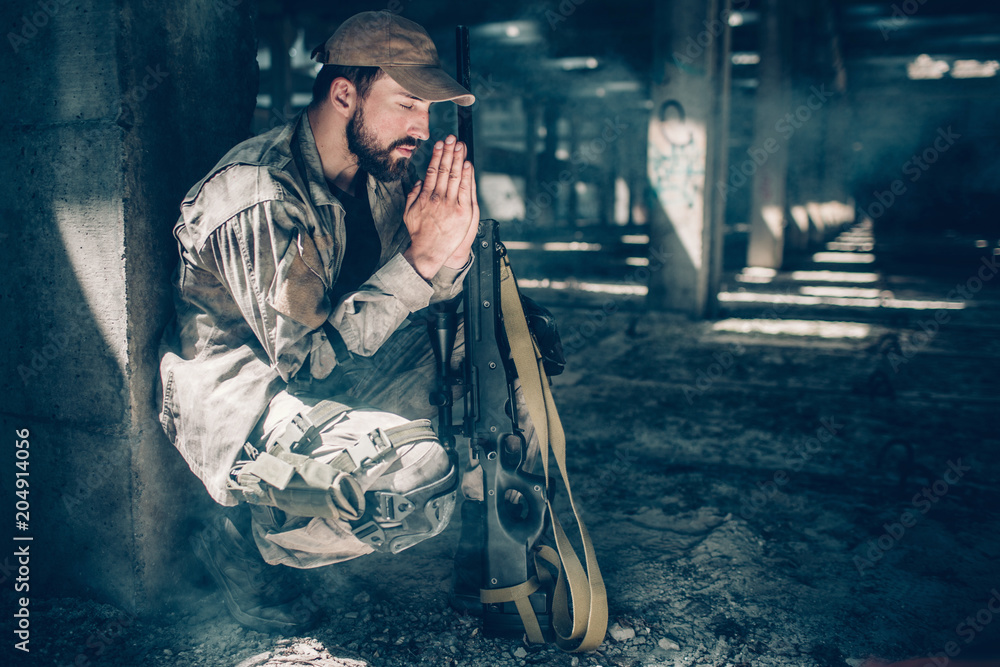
[403,135,479,280]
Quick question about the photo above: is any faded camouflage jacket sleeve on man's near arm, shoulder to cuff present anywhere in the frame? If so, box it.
[203,200,471,382]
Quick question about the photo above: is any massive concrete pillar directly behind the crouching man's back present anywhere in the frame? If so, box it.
[0,0,256,611]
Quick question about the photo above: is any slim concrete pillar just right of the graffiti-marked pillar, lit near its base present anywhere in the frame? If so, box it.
[747,0,794,269]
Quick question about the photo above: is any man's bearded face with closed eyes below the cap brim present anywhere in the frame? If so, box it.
[347,76,430,183]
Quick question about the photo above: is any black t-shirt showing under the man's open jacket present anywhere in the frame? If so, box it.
[327,172,382,304]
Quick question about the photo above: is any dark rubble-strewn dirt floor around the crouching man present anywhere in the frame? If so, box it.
[9,226,1000,667]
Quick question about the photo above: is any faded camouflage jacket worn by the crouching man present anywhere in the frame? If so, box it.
[160,112,468,505]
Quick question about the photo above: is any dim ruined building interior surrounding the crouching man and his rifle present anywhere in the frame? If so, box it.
[0,0,1000,667]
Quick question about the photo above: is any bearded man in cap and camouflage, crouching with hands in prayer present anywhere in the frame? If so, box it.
[160,11,479,633]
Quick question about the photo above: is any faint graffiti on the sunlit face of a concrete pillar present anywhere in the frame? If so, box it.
[649,100,706,209]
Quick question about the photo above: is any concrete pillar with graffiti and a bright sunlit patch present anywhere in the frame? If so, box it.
[647,0,730,317]
